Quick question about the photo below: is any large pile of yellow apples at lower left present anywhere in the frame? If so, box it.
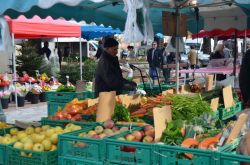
[7,123,81,155]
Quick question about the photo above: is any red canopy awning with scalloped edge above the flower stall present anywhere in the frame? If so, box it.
[5,15,81,39]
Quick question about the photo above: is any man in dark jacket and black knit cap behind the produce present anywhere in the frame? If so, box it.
[95,38,136,97]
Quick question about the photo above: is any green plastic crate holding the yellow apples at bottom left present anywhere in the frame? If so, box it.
[7,146,58,165]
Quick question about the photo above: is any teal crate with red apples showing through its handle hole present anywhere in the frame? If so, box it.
[105,128,155,165]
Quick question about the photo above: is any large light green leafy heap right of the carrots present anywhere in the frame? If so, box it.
[170,95,212,120]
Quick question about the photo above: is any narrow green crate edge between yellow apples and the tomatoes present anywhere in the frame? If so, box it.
[41,117,97,129]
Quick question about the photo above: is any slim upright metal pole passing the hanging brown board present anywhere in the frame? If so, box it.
[175,7,179,94]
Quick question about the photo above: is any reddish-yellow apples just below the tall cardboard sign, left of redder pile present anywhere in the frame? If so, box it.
[79,120,128,139]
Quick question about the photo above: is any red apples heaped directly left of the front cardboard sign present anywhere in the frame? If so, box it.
[117,125,155,143]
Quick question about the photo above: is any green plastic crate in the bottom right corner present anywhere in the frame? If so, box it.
[220,153,250,165]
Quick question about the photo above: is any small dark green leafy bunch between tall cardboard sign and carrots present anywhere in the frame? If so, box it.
[112,104,131,122]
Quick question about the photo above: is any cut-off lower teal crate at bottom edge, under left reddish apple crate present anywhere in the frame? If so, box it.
[58,156,104,165]
